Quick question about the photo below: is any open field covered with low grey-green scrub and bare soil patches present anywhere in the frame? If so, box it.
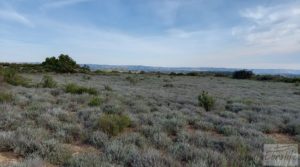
[0,73,300,167]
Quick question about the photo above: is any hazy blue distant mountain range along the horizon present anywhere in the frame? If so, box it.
[87,64,300,76]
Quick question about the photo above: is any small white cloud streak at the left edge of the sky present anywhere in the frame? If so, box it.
[0,9,34,27]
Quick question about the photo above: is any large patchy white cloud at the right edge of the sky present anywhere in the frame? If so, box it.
[232,3,300,47]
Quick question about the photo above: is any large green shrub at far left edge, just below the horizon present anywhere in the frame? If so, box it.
[3,68,30,87]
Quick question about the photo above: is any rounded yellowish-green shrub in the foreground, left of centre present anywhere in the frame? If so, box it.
[99,114,131,136]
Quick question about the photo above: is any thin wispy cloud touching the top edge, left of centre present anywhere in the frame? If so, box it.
[41,0,91,9]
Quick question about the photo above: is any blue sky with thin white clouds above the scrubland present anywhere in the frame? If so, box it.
[0,0,300,69]
